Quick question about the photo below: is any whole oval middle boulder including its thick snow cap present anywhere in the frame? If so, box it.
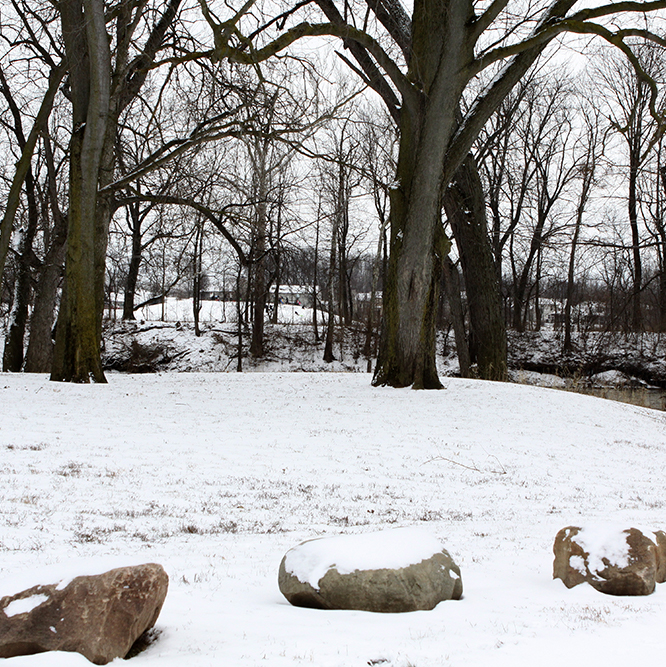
[278,528,462,612]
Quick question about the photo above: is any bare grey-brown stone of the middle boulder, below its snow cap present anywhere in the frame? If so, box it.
[278,538,462,612]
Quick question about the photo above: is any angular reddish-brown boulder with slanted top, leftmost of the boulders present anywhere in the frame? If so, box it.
[0,563,169,665]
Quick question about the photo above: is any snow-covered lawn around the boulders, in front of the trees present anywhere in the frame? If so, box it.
[0,373,666,667]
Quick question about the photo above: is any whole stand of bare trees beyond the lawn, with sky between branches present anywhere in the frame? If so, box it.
[0,0,666,388]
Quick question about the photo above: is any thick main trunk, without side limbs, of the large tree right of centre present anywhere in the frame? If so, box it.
[373,0,473,389]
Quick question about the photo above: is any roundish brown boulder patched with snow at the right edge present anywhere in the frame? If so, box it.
[553,526,666,595]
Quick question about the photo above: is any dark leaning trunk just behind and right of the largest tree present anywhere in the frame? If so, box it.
[444,156,507,380]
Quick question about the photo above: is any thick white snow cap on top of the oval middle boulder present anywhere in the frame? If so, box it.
[285,527,443,590]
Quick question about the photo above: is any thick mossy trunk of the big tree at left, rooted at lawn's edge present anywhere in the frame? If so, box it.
[51,0,110,382]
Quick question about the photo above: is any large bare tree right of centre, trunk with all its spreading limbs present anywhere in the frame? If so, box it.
[193,0,665,388]
